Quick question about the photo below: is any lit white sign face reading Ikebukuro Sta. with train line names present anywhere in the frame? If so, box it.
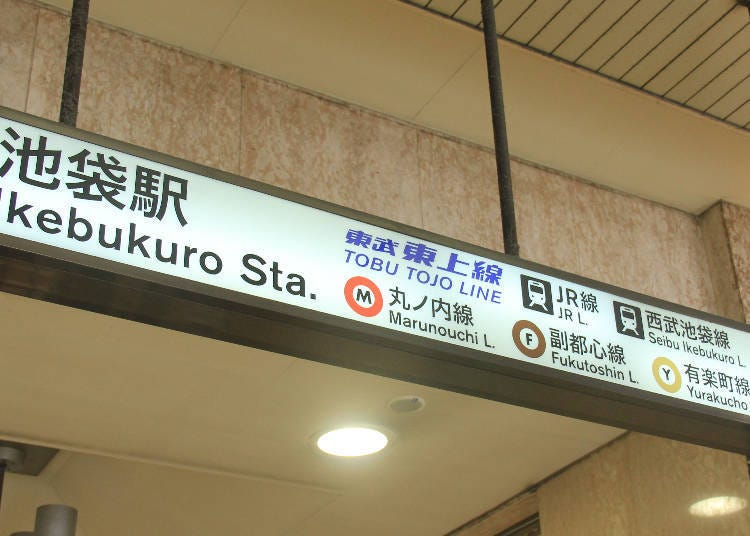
[0,113,750,415]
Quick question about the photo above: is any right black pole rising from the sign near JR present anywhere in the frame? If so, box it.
[482,0,518,256]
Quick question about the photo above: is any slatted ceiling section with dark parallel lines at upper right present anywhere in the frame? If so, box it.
[412,0,750,129]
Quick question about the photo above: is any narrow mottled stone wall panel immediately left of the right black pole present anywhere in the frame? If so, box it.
[418,132,503,251]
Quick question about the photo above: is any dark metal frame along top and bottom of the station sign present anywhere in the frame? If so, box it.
[0,107,750,455]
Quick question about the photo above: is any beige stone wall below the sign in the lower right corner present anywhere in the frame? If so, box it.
[539,433,750,536]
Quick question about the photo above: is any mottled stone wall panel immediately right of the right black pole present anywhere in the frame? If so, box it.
[512,162,718,312]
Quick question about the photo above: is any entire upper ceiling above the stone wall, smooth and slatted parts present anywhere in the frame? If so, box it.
[38,0,750,213]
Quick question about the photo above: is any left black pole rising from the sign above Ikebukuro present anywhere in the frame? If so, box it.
[60,0,89,127]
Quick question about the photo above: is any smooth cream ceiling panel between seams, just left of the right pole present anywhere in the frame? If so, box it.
[214,0,482,117]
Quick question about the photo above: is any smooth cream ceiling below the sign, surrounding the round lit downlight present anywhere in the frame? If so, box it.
[0,294,621,536]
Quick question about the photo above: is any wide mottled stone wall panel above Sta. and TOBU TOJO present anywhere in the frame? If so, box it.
[240,74,422,226]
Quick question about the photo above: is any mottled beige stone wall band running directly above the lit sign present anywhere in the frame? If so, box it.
[0,0,726,313]
